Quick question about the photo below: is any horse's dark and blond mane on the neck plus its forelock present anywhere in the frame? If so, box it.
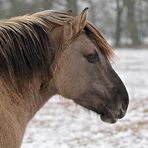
[0,10,112,89]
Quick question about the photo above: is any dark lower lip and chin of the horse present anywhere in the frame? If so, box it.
[100,108,118,123]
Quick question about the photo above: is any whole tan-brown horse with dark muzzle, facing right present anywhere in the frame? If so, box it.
[0,8,129,148]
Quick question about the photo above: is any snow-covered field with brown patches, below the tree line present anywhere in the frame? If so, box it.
[21,50,148,148]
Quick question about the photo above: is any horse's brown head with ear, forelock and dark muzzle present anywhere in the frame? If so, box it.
[53,9,129,123]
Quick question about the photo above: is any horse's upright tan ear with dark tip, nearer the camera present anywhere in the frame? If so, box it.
[73,8,88,34]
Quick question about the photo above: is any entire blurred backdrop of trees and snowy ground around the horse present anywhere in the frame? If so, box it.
[0,0,148,148]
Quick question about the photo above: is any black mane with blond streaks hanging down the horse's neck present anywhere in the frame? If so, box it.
[0,13,53,87]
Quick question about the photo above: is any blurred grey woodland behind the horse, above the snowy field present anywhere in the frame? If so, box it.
[0,0,148,48]
